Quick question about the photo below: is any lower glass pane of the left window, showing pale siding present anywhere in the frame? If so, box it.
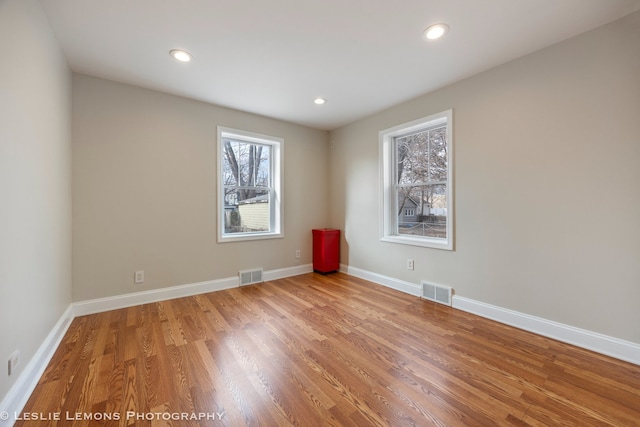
[224,188,271,233]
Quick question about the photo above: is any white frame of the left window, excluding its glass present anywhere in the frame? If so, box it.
[217,126,284,243]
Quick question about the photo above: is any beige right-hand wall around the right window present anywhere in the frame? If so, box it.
[330,13,640,343]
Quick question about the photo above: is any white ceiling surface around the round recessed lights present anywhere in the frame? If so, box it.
[41,0,640,129]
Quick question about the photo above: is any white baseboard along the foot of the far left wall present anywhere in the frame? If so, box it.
[0,305,74,427]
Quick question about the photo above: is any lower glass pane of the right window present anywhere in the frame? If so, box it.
[397,184,447,239]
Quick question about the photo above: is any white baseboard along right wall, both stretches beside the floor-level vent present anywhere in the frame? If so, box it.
[340,264,640,365]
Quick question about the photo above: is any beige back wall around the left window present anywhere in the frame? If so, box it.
[73,75,329,301]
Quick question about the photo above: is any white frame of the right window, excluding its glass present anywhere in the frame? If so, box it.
[378,110,454,250]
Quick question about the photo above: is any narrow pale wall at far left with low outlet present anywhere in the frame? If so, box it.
[0,0,71,402]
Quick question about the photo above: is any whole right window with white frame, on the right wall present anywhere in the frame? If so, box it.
[380,110,453,250]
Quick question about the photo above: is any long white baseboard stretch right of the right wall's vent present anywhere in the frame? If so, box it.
[453,295,640,365]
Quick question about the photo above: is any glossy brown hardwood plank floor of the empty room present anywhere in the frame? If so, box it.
[16,273,640,427]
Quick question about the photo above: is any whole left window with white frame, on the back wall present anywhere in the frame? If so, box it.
[218,126,283,242]
